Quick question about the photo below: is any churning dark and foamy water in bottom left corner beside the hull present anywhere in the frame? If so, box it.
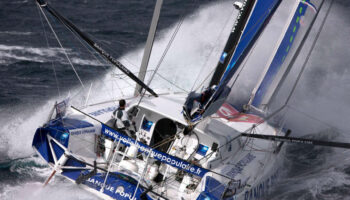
[0,157,96,200]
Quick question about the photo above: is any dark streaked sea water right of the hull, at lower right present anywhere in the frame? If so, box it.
[266,129,350,200]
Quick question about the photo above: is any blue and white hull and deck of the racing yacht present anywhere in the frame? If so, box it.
[33,95,284,199]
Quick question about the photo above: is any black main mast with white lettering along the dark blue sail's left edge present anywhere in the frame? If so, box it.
[209,0,256,86]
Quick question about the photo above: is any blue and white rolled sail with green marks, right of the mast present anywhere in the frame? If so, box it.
[248,0,322,109]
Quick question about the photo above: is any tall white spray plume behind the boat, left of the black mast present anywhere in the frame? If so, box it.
[84,2,237,102]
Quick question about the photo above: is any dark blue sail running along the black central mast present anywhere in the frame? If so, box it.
[186,0,280,117]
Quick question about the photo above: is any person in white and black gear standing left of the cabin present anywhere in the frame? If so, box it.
[112,99,135,137]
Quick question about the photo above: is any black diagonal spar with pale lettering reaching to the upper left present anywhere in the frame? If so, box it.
[37,0,158,97]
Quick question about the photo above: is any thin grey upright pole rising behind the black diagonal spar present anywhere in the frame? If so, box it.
[134,0,163,96]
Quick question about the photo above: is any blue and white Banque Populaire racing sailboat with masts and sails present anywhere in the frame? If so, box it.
[32,0,350,200]
